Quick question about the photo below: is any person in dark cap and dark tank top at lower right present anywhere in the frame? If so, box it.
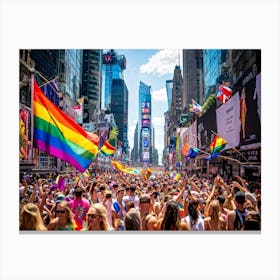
[227,191,248,230]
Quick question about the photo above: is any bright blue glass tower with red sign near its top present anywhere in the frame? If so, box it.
[101,49,126,110]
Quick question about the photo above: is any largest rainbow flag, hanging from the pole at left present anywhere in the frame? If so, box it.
[33,82,98,172]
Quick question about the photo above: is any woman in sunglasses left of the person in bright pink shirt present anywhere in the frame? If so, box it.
[48,200,77,230]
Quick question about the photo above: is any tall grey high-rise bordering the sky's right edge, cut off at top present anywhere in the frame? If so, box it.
[183,50,203,109]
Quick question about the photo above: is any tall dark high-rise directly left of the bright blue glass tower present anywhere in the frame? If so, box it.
[81,50,102,123]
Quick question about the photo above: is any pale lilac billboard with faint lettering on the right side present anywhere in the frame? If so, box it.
[216,92,241,149]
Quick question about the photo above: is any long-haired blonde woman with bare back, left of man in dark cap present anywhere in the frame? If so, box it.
[204,199,226,230]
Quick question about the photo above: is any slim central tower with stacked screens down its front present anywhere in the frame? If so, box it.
[139,81,152,163]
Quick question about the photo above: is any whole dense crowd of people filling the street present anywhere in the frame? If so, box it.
[19,166,261,232]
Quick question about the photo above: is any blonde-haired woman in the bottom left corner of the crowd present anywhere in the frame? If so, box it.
[19,203,47,230]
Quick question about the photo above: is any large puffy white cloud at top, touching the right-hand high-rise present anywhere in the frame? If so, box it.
[140,49,178,76]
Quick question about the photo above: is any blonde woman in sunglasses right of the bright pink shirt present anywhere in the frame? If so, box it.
[83,203,113,231]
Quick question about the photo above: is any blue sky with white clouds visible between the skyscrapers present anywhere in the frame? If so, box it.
[115,49,182,163]
